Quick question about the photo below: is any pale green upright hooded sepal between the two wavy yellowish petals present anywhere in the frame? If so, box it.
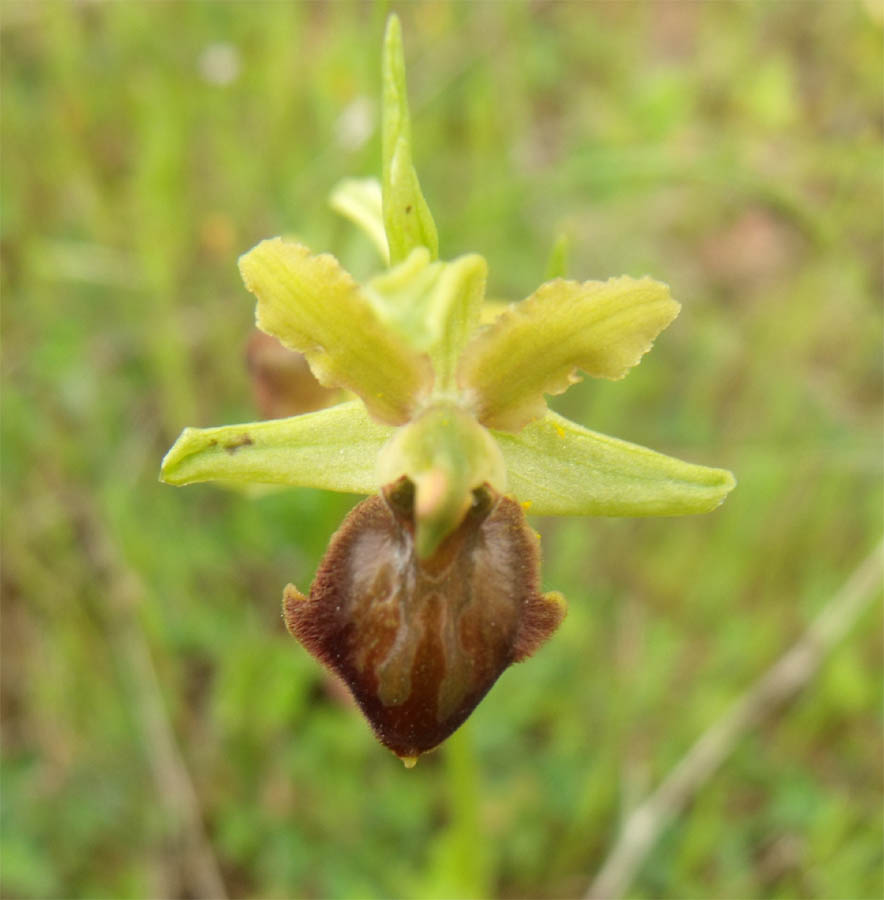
[365,247,488,393]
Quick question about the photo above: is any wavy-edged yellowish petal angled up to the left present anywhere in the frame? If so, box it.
[239,238,432,425]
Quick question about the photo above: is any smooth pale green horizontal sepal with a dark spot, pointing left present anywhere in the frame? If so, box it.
[160,400,393,494]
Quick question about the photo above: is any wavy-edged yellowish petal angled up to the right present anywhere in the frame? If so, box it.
[457,277,680,431]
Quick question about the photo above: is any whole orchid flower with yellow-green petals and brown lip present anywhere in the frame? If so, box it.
[161,16,735,764]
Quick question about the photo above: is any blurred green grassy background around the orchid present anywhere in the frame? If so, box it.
[0,0,884,898]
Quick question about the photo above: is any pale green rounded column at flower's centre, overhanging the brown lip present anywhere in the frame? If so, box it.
[378,405,506,559]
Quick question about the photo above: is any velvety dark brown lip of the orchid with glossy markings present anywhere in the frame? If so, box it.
[284,478,565,760]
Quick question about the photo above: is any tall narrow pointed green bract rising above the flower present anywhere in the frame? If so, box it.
[381,15,439,264]
